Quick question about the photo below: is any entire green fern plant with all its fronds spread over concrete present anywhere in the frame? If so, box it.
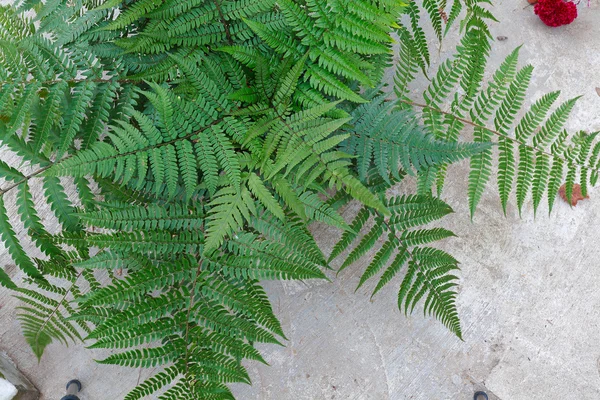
[0,0,600,399]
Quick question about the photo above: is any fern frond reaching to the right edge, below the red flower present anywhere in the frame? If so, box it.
[396,26,599,216]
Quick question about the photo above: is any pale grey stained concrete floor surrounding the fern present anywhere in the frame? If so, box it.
[0,0,600,400]
